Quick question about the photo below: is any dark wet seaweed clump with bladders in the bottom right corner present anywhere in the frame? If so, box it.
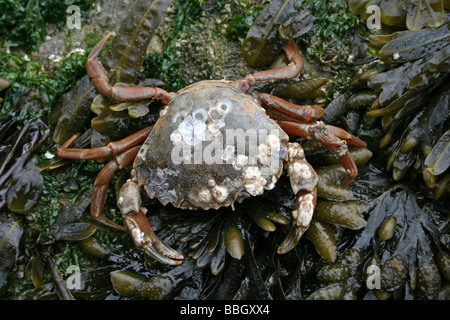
[308,186,449,300]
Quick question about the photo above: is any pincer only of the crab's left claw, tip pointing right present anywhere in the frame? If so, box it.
[125,210,184,266]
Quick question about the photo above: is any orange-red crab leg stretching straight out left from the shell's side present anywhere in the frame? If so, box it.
[57,126,153,160]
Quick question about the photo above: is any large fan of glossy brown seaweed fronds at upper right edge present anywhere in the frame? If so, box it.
[342,8,450,199]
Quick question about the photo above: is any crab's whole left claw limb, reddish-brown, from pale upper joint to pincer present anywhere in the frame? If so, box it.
[117,175,184,265]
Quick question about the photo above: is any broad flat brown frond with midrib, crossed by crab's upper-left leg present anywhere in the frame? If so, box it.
[50,0,171,144]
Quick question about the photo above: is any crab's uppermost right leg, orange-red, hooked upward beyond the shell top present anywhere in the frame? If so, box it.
[235,39,303,92]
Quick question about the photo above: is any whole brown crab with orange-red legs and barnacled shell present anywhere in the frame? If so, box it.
[57,33,366,265]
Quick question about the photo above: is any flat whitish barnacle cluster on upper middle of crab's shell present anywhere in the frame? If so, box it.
[170,99,233,146]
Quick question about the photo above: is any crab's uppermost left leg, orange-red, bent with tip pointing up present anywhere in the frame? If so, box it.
[86,32,175,104]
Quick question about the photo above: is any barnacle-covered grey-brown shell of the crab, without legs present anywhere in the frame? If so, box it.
[134,81,289,209]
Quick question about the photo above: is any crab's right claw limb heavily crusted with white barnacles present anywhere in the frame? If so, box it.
[278,142,319,253]
